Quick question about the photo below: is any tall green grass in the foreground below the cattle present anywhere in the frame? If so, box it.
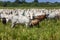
[0,19,60,40]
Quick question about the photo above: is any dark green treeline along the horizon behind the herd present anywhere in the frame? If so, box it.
[0,0,60,7]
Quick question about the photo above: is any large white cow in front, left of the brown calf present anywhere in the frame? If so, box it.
[11,15,30,28]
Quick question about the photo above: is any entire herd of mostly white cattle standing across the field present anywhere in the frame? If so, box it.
[0,9,60,28]
